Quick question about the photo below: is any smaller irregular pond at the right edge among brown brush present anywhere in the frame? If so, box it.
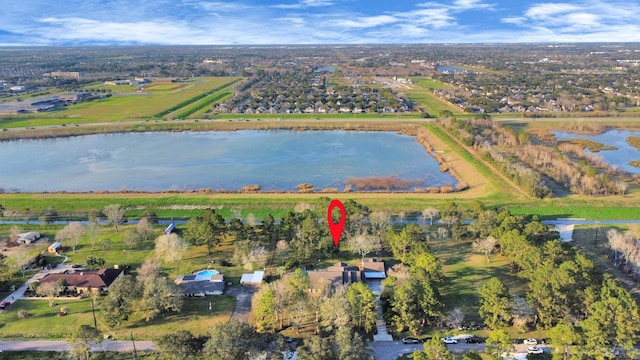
[554,130,640,174]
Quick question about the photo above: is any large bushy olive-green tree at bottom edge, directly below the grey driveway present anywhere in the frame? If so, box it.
[204,319,269,360]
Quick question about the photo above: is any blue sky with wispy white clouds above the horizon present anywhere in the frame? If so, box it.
[0,0,640,46]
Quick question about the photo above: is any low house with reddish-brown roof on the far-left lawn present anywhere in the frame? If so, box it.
[40,268,124,294]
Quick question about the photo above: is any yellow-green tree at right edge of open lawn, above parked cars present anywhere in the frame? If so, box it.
[478,277,511,329]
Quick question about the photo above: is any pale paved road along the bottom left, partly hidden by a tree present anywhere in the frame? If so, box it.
[0,340,154,352]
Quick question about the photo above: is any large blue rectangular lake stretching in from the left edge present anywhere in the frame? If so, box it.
[0,131,456,192]
